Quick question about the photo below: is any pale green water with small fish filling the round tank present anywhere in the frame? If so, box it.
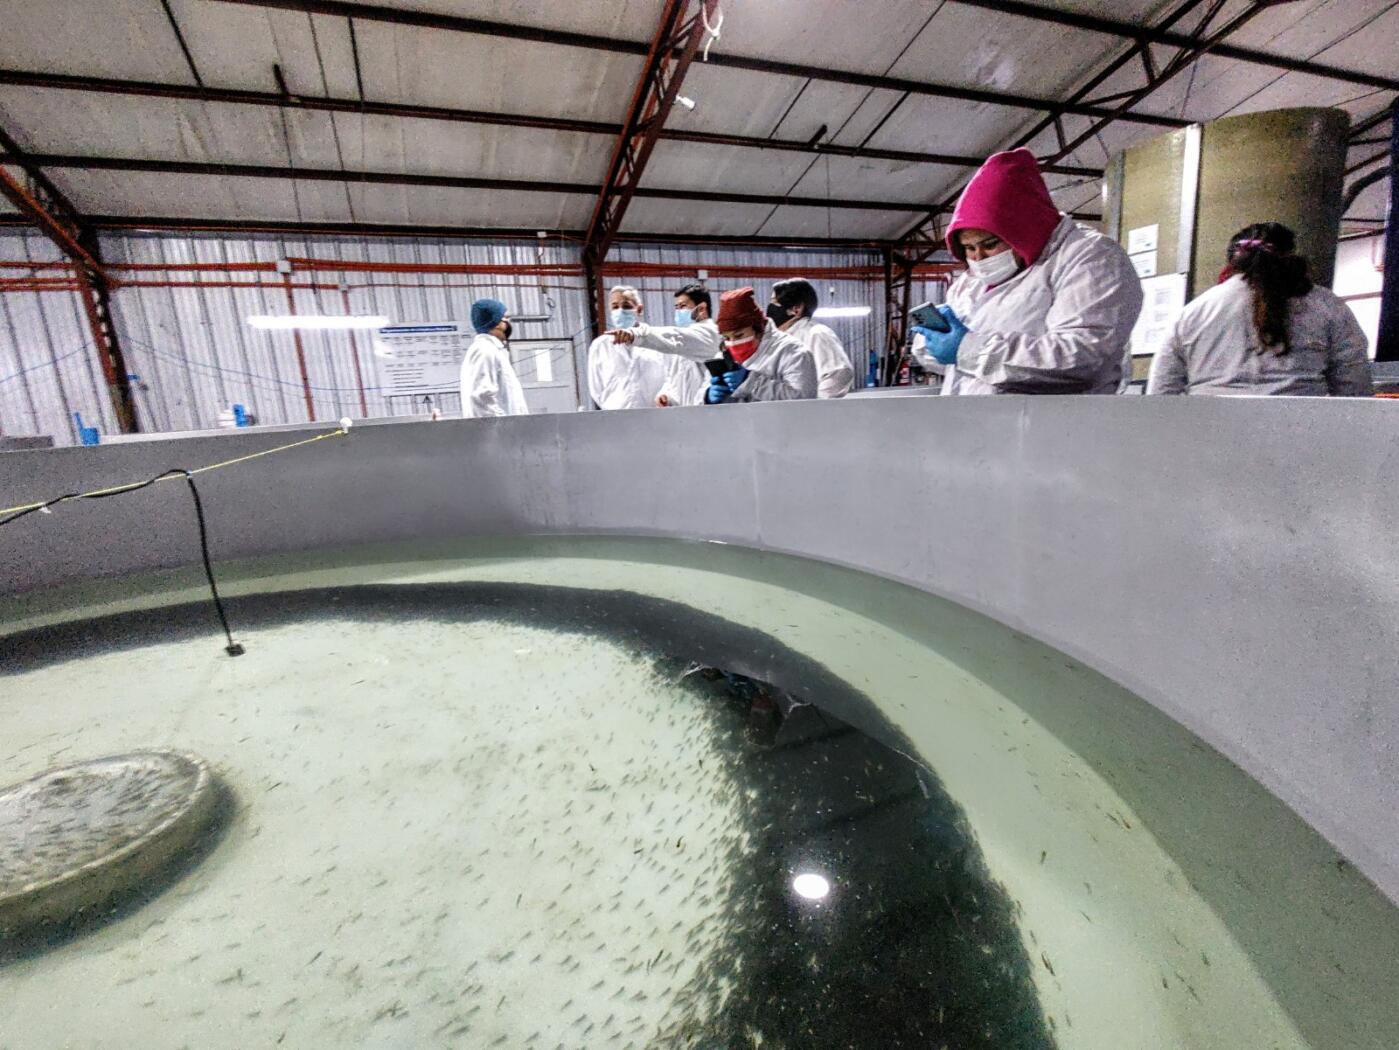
[0,540,1399,1050]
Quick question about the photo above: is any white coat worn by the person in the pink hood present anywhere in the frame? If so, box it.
[943,215,1142,394]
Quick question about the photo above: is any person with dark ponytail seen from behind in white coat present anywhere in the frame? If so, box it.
[1146,222,1374,397]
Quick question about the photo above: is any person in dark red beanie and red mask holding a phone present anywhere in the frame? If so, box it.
[705,288,816,404]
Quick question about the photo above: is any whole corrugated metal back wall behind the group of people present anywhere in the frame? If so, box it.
[0,232,919,443]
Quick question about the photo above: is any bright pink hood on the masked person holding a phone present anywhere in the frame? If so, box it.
[947,150,1060,266]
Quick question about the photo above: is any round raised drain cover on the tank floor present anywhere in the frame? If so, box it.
[0,751,220,937]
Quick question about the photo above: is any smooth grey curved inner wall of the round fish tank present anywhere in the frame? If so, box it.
[0,397,1399,900]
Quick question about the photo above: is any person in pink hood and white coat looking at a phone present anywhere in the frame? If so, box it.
[916,150,1142,394]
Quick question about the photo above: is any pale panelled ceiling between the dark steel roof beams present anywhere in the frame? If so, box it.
[0,0,1399,239]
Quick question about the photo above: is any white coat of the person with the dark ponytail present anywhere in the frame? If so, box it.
[1146,274,1374,397]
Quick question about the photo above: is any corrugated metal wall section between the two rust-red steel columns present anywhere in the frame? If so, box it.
[104,236,588,431]
